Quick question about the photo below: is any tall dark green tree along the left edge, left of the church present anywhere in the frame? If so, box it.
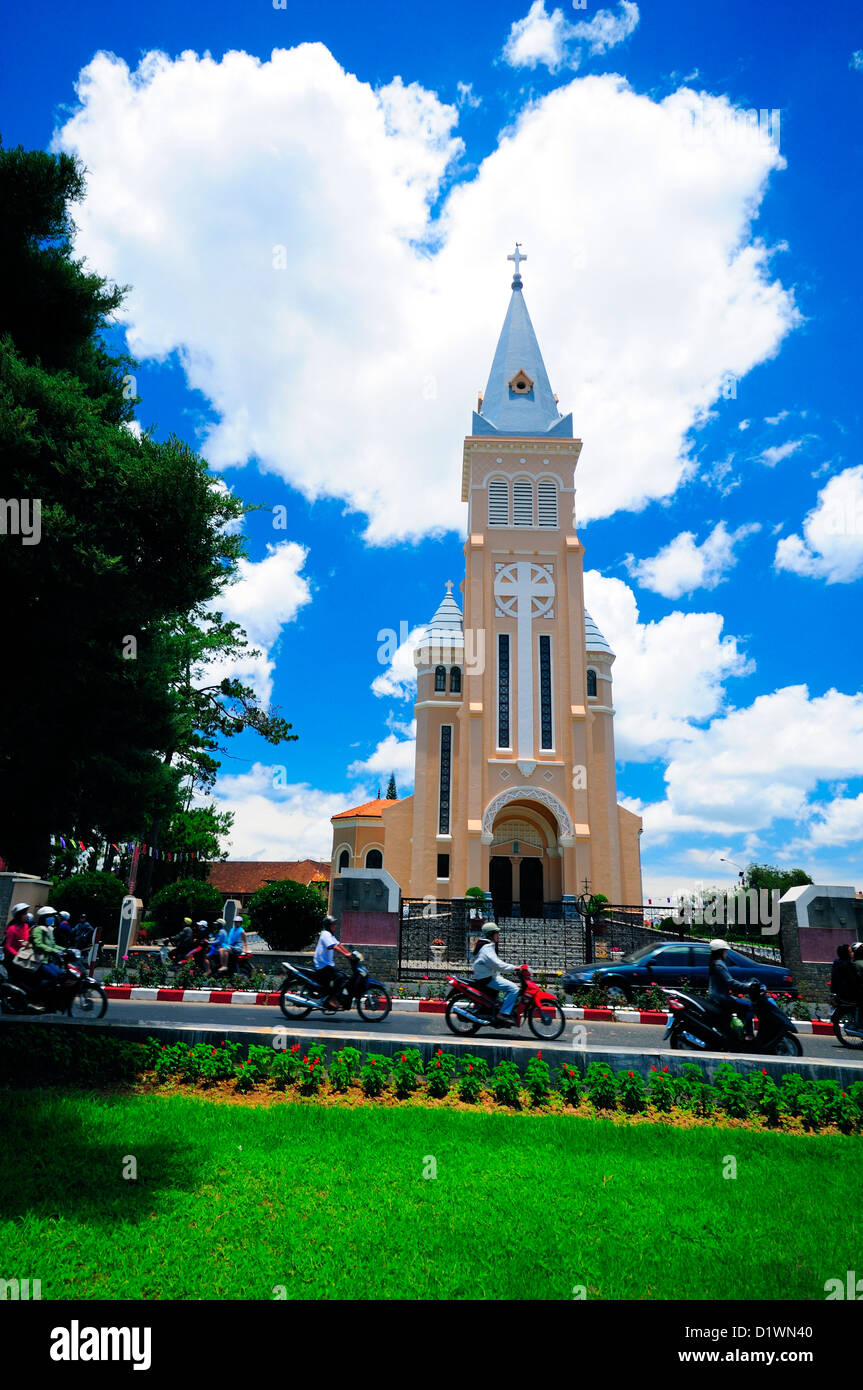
[0,146,296,888]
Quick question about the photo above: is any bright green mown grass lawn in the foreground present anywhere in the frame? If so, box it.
[0,1091,863,1300]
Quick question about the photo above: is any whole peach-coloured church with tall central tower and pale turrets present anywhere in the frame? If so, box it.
[332,246,642,917]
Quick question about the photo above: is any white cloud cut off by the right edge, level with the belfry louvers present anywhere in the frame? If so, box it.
[774,464,863,584]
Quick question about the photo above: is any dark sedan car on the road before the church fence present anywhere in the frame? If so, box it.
[563,941,798,999]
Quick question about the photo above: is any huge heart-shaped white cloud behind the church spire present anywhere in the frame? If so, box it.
[56,51,796,543]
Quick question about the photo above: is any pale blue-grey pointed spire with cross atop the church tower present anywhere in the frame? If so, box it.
[472,242,573,439]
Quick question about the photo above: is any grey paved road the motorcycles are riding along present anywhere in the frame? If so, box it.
[18,999,863,1068]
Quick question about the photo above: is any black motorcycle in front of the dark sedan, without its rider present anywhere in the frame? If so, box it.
[663,980,803,1056]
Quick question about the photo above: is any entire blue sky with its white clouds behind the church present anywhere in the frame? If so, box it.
[6,0,863,895]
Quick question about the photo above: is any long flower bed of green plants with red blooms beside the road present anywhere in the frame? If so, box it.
[6,1029,863,1134]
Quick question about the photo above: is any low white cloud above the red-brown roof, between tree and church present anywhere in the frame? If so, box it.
[213,763,355,859]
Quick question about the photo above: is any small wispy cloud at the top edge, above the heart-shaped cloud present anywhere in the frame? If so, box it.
[503,0,639,72]
